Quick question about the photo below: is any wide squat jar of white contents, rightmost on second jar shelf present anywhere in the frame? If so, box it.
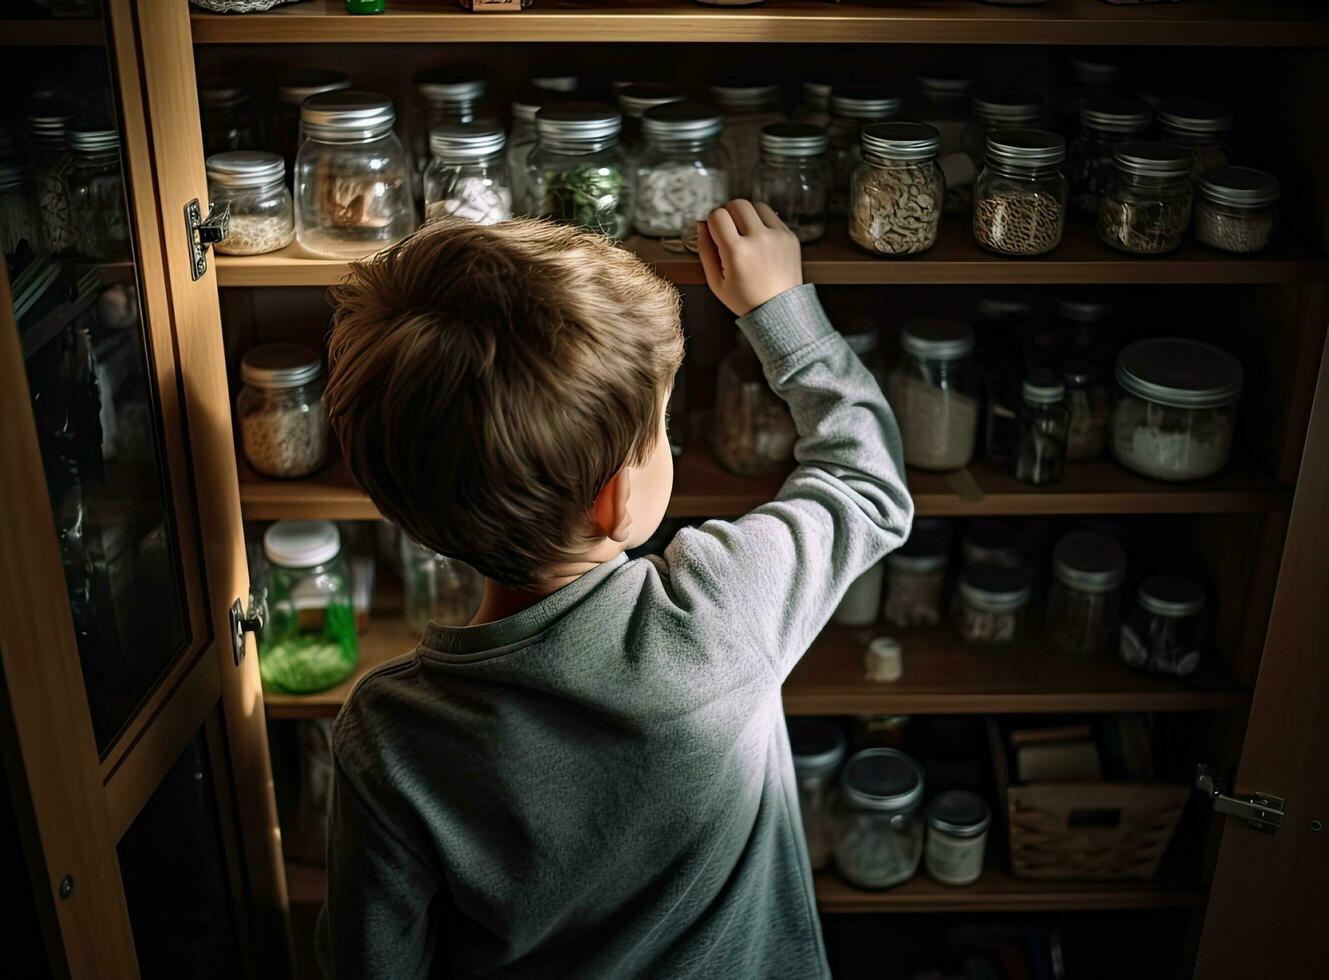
[1112,336,1243,480]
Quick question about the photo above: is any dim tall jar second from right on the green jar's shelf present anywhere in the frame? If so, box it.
[1047,531,1126,657]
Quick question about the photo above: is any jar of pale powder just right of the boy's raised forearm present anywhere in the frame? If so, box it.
[888,316,978,471]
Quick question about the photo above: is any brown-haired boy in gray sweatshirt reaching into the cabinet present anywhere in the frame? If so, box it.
[322,201,913,980]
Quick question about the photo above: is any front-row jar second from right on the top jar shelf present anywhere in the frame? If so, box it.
[1098,142,1191,255]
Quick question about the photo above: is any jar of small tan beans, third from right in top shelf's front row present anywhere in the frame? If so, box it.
[974,129,1066,255]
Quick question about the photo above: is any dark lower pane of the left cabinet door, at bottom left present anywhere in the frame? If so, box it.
[116,733,241,980]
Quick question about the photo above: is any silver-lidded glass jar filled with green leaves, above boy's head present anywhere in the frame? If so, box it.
[526,102,633,239]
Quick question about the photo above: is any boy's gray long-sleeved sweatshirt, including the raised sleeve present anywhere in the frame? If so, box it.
[320,279,913,980]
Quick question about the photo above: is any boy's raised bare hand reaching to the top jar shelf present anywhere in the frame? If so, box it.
[698,198,803,316]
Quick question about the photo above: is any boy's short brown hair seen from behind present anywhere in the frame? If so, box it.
[326,219,683,588]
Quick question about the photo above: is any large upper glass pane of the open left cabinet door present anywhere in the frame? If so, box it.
[0,21,190,751]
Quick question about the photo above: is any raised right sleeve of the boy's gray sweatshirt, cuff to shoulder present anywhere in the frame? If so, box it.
[665,285,913,681]
